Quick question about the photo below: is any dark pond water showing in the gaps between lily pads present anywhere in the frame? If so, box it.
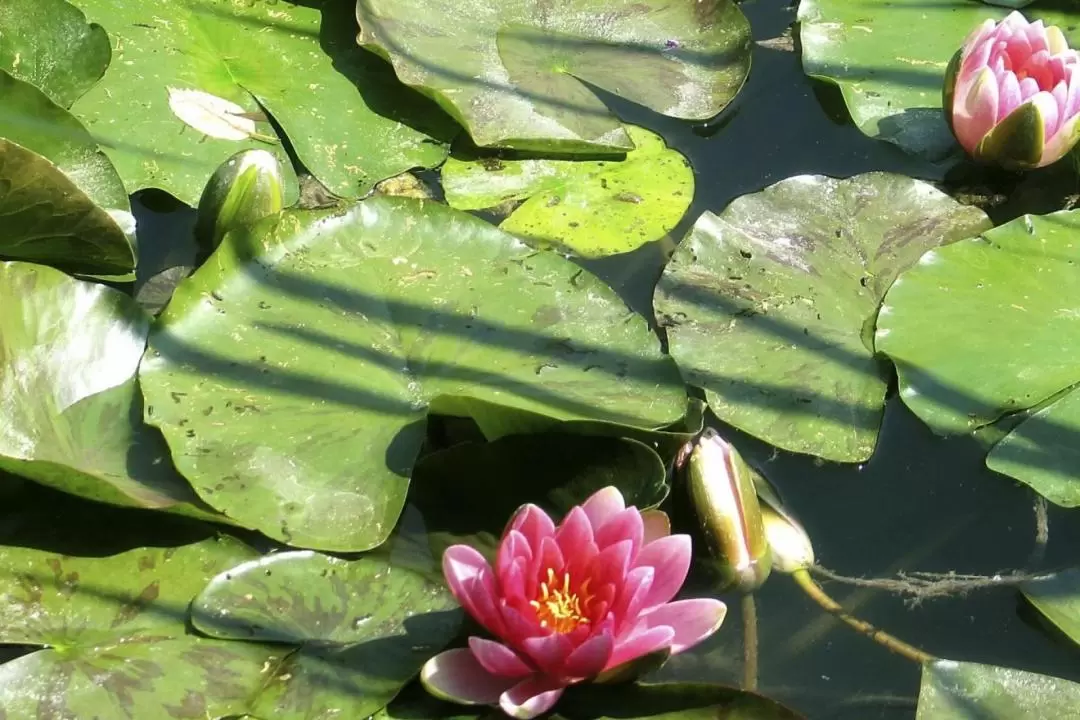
[0,0,1080,720]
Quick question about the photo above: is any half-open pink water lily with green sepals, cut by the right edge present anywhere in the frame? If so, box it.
[943,12,1080,169]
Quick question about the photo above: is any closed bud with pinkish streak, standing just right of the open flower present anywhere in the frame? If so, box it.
[687,427,772,593]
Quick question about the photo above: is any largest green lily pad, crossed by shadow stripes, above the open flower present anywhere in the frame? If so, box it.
[140,195,686,551]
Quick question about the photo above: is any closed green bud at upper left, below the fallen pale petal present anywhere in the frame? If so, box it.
[195,150,285,253]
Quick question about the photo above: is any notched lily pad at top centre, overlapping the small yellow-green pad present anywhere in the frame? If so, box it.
[356,0,751,152]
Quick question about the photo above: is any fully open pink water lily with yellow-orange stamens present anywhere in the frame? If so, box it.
[420,487,727,718]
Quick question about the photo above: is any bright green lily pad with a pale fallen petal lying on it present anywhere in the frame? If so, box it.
[72,0,453,205]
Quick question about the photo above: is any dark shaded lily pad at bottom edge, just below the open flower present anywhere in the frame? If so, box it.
[554,682,802,720]
